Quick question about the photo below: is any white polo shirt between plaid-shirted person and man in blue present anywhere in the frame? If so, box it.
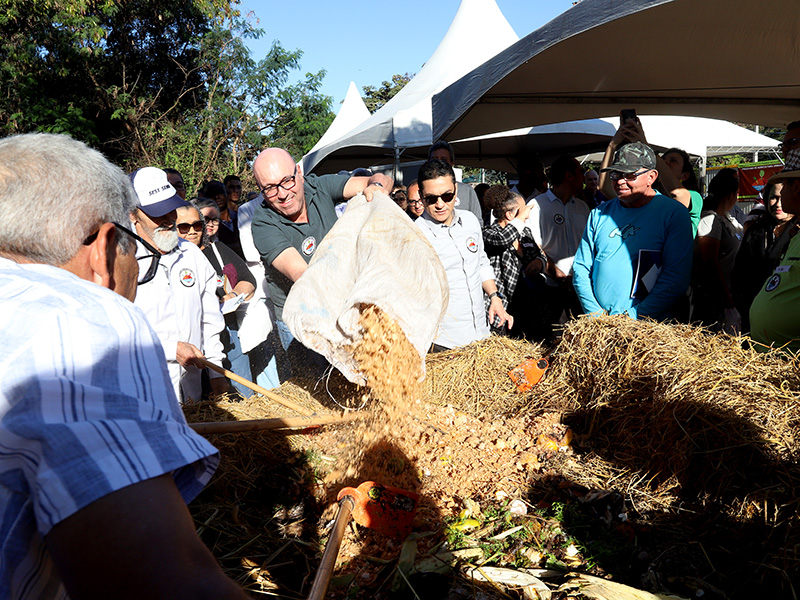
[525,190,590,285]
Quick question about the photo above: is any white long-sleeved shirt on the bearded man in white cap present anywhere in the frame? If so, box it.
[134,239,225,400]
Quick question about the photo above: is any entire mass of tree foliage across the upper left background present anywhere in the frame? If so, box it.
[0,0,333,189]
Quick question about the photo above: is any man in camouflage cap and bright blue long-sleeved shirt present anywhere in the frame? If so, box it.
[572,142,693,319]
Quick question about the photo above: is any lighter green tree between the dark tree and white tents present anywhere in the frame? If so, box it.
[128,21,333,190]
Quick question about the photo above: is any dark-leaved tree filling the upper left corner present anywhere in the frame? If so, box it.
[0,0,217,149]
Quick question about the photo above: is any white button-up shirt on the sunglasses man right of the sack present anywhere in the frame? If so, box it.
[414,209,494,348]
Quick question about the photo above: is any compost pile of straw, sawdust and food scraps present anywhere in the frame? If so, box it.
[185,311,800,598]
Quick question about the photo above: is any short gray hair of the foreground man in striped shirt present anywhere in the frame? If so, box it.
[0,133,136,266]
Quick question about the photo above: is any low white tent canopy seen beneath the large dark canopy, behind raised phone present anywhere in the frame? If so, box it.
[452,115,778,172]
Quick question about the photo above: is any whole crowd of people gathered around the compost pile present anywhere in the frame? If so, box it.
[0,120,800,598]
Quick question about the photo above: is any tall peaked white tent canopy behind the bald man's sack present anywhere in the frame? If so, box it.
[303,0,519,173]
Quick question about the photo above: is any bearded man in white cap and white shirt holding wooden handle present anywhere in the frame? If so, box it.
[131,167,229,401]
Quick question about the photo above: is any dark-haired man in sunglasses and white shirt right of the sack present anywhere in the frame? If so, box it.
[414,158,514,351]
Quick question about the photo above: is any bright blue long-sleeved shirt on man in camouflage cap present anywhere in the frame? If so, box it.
[573,194,693,319]
